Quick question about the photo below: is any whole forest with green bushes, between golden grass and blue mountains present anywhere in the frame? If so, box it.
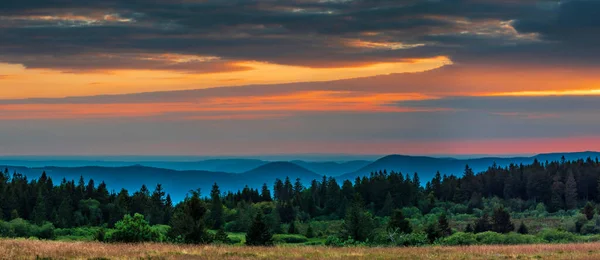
[0,155,600,247]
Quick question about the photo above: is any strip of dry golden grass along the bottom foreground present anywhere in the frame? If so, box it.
[0,240,600,259]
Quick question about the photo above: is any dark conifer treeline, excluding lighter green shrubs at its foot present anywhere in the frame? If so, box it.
[0,158,600,244]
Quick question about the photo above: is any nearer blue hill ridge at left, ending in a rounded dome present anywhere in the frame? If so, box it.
[0,162,321,201]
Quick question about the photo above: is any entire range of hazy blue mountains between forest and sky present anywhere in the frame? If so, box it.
[0,152,600,201]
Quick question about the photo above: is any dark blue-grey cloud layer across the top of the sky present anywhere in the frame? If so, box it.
[0,0,600,72]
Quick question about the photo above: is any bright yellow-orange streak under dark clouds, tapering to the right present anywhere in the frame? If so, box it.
[0,55,451,99]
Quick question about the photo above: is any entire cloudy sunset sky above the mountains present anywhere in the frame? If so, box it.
[0,0,600,155]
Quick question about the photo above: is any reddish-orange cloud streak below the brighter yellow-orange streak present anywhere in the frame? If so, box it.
[0,91,440,120]
